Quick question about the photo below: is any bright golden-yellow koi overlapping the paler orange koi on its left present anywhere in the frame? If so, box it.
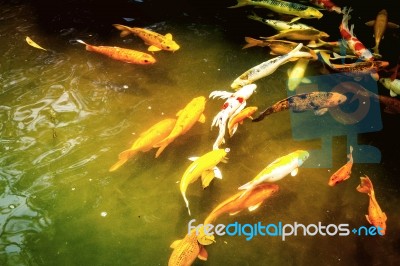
[154,96,206,158]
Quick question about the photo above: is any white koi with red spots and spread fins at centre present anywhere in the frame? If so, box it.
[209,84,257,150]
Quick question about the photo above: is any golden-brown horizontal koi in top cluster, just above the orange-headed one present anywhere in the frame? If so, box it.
[261,29,329,41]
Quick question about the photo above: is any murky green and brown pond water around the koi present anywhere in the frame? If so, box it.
[0,1,400,265]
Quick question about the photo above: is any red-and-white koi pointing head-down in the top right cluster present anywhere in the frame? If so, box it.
[339,7,374,61]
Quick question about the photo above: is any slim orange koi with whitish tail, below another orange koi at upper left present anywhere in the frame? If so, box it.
[76,40,156,65]
